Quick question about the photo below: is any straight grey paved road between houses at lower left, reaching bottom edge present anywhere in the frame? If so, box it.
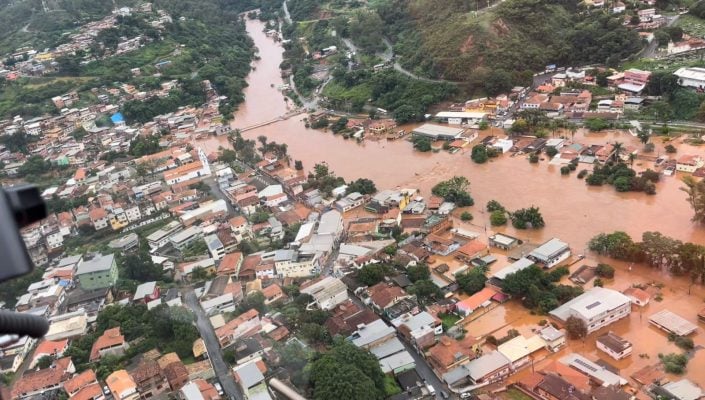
[183,289,244,400]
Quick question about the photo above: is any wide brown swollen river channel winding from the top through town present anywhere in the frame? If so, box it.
[195,21,705,252]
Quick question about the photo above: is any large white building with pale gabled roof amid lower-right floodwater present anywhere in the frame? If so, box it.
[550,287,631,334]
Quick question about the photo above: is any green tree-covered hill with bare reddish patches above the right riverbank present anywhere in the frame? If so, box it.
[377,0,642,94]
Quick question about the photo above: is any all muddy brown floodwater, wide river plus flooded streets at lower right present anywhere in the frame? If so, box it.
[192,17,705,386]
